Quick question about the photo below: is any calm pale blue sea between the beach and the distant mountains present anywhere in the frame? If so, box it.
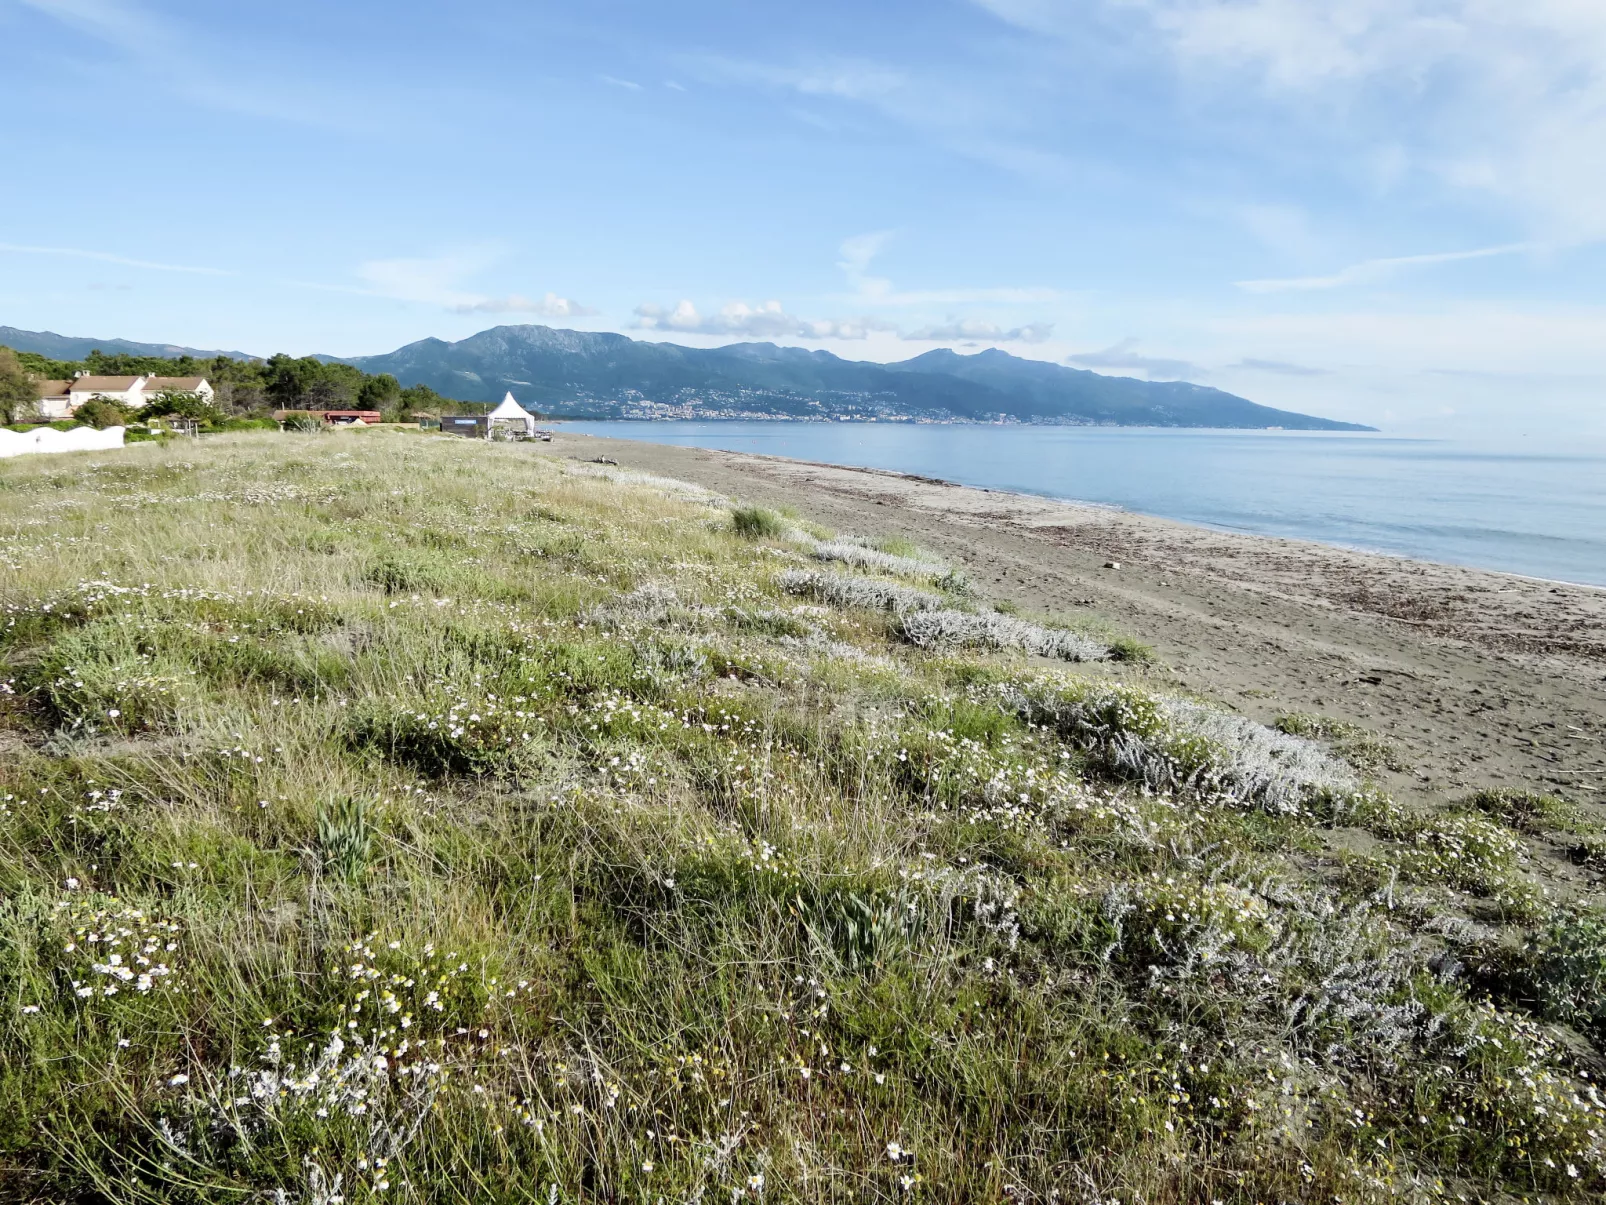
[564,423,1606,586]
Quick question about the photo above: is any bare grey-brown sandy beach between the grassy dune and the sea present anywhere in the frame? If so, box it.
[551,431,1606,816]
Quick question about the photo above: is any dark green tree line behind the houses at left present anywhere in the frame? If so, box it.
[0,347,482,423]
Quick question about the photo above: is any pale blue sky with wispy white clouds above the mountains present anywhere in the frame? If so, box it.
[0,0,1606,435]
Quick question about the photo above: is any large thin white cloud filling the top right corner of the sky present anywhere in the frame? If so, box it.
[995,0,1606,243]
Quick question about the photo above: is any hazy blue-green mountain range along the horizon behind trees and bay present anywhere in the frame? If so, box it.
[0,326,1373,431]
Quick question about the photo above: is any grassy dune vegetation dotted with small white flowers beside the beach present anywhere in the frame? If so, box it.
[0,431,1606,1205]
